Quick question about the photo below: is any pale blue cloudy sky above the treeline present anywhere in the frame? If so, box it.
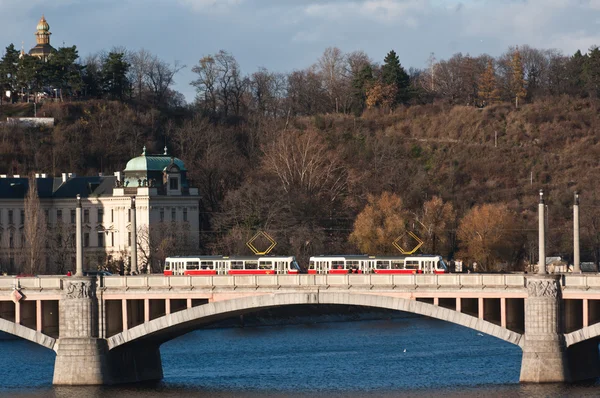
[0,0,600,101]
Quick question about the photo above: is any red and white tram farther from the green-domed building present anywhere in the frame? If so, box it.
[308,255,448,274]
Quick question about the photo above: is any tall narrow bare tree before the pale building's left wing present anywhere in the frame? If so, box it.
[23,176,47,275]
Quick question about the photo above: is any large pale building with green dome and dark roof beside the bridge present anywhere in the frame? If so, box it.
[0,148,200,273]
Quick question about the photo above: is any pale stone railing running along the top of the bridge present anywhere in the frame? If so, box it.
[5,274,600,291]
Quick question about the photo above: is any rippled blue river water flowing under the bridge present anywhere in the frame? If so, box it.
[0,318,600,398]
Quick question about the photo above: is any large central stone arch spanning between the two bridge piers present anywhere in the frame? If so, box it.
[108,292,523,350]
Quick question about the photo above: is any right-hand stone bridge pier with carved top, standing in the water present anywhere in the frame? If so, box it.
[520,275,573,383]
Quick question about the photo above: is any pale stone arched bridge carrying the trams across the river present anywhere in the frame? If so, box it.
[0,274,600,385]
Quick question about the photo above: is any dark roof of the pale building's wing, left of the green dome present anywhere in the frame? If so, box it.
[0,176,116,199]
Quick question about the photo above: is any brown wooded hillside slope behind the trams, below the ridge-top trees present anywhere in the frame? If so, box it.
[0,96,600,270]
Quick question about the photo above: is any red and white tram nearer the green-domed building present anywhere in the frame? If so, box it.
[164,256,300,276]
